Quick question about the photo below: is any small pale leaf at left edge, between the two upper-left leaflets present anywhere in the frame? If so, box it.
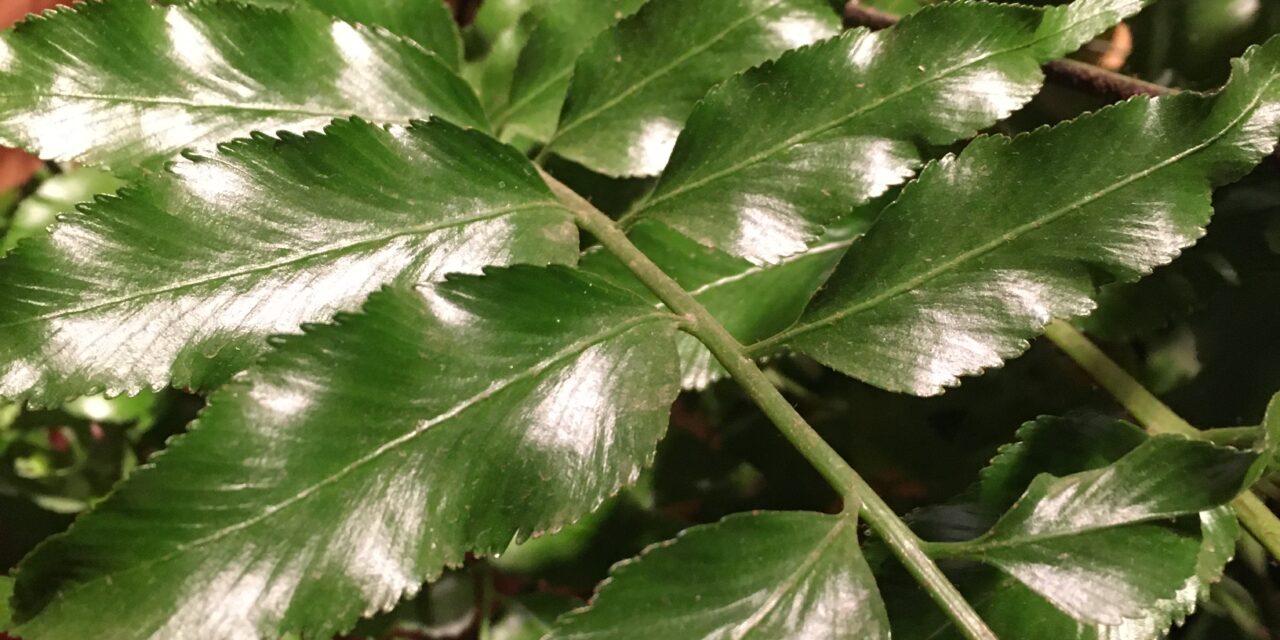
[0,168,124,256]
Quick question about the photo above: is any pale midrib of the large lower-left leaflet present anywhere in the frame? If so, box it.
[30,312,672,611]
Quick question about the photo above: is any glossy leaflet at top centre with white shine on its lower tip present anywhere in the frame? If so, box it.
[547,0,840,175]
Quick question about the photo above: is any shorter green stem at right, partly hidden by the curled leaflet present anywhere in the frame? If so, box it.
[1044,320,1280,559]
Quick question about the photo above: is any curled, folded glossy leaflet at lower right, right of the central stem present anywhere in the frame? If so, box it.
[963,435,1257,625]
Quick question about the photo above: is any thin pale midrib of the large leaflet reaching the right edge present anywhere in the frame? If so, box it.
[749,81,1274,353]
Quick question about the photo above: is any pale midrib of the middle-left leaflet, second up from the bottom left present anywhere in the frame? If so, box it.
[0,201,557,329]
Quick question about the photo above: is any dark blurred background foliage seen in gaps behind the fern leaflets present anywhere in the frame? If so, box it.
[0,0,1280,640]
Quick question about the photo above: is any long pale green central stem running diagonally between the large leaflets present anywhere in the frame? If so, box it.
[543,173,996,640]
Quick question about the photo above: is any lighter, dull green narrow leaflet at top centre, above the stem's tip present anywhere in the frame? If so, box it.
[493,0,646,142]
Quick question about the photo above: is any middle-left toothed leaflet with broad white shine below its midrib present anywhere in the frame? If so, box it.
[0,120,577,404]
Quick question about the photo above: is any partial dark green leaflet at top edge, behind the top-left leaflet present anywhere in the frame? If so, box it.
[238,0,462,70]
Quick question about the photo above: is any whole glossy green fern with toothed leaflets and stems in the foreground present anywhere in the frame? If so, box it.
[0,0,1280,640]
